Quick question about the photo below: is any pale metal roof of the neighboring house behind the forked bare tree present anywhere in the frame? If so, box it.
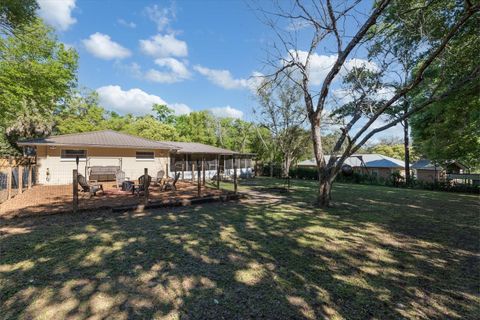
[298,153,405,169]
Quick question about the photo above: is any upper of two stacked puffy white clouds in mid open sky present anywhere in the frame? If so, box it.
[140,34,188,58]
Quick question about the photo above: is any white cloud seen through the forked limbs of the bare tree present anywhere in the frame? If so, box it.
[287,50,378,85]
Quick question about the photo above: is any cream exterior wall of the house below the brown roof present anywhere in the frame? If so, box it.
[37,146,168,185]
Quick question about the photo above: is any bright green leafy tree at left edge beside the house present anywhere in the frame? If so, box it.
[0,19,78,153]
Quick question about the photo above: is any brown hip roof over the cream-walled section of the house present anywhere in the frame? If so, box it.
[18,130,177,150]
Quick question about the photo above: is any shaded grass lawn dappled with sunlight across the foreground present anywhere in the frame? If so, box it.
[0,178,480,319]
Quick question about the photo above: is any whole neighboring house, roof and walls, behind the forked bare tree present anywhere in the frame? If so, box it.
[298,153,405,179]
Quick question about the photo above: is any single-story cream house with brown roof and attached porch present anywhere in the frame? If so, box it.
[18,130,252,185]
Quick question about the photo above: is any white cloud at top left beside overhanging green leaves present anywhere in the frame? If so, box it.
[38,0,77,31]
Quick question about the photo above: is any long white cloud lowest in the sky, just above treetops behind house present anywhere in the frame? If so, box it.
[97,85,191,115]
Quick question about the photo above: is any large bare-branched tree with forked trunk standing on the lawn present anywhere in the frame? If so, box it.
[263,0,480,206]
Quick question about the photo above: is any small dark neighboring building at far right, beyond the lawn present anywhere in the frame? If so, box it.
[411,159,469,182]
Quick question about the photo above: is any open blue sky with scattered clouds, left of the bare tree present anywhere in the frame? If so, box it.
[38,0,399,140]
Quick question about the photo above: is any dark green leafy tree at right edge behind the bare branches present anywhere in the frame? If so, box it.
[411,1,480,167]
